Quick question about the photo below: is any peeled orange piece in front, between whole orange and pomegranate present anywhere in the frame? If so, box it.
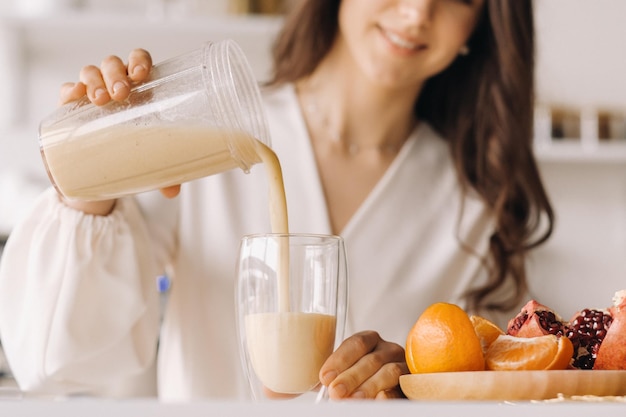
[485,334,574,371]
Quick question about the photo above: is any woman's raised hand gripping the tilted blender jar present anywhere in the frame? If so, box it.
[59,49,180,215]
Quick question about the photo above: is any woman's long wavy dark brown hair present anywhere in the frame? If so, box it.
[270,0,554,310]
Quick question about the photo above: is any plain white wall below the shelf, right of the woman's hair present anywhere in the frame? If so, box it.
[530,162,626,319]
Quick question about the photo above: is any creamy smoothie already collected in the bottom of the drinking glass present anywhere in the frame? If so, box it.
[245,313,336,394]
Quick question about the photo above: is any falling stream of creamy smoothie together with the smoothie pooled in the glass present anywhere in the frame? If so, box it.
[249,142,336,394]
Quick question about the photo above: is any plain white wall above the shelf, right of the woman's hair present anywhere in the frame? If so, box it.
[534,0,626,110]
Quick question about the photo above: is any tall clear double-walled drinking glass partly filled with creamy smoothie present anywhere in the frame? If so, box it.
[236,234,347,401]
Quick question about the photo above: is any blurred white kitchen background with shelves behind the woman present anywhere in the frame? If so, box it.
[0,0,626,382]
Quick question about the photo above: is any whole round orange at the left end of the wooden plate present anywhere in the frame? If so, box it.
[405,303,485,374]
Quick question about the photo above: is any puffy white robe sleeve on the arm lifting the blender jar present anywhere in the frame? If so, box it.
[0,189,163,394]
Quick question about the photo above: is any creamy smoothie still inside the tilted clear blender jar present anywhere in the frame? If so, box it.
[40,124,261,200]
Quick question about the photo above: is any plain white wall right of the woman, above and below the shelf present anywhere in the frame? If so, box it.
[531,0,626,319]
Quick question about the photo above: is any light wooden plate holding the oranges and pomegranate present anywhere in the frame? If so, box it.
[400,370,626,401]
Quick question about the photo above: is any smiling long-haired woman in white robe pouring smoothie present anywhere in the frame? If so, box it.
[0,0,553,400]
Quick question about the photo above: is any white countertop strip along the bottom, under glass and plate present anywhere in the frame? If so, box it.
[0,397,626,417]
